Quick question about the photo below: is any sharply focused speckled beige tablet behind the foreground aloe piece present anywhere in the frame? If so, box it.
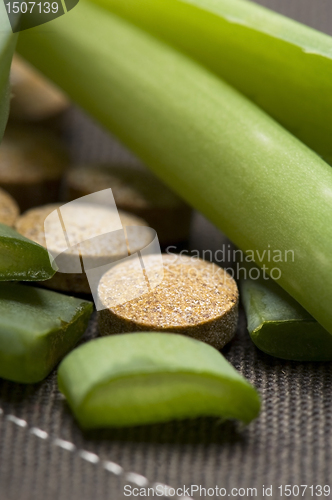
[98,255,239,349]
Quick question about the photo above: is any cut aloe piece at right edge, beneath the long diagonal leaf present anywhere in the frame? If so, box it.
[240,279,332,361]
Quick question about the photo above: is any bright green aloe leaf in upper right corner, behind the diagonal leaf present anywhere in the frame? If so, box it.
[89,0,332,164]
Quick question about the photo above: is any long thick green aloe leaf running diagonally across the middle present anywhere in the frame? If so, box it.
[16,1,332,333]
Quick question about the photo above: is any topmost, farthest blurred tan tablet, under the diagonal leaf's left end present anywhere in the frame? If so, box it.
[10,55,69,122]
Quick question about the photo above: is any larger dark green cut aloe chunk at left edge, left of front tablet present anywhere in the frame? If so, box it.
[0,283,93,383]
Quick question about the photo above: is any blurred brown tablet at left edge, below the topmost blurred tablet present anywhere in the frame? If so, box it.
[0,126,68,210]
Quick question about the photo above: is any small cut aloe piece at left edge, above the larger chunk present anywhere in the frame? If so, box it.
[0,224,56,281]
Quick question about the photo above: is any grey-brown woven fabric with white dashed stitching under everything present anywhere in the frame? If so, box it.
[0,0,332,500]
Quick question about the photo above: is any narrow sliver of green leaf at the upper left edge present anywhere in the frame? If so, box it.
[0,2,17,141]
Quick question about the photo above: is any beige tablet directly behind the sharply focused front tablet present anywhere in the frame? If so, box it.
[15,203,151,293]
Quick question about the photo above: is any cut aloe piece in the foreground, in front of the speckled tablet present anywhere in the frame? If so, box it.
[58,332,260,428]
